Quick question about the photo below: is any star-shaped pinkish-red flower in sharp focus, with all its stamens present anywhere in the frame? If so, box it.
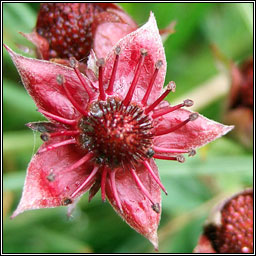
[6,14,232,248]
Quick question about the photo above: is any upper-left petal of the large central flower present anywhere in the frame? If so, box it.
[6,46,93,119]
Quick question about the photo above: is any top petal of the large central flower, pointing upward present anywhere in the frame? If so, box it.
[104,13,166,104]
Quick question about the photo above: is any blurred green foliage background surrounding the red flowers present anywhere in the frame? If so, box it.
[3,3,253,253]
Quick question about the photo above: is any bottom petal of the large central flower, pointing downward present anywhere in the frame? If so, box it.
[106,160,161,249]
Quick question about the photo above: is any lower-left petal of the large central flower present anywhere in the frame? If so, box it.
[12,138,93,218]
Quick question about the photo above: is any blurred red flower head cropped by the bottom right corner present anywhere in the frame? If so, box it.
[194,189,253,254]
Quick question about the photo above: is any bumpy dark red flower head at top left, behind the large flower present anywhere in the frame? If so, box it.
[22,3,137,60]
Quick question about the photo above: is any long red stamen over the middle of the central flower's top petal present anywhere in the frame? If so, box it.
[123,49,147,106]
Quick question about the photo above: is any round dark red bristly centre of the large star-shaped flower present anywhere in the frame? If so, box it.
[79,98,153,168]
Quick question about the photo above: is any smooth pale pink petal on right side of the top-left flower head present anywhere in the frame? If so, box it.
[93,9,137,58]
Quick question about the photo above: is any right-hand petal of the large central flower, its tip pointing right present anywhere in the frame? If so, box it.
[154,105,234,149]
